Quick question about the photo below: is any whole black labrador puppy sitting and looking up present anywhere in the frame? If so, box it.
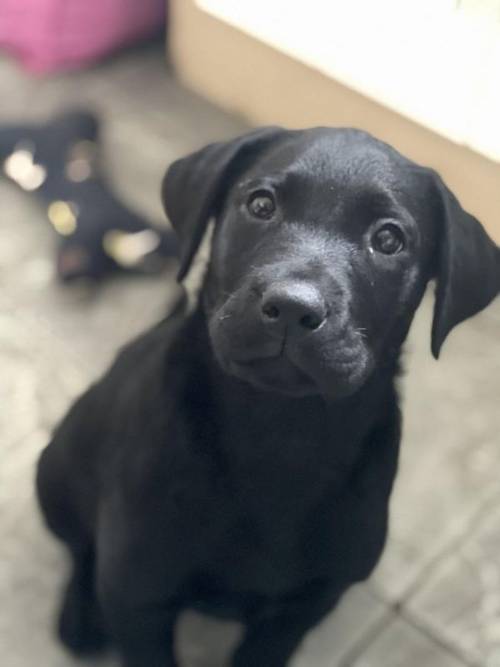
[38,128,500,667]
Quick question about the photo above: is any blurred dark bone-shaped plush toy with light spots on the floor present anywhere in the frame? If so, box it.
[0,111,176,281]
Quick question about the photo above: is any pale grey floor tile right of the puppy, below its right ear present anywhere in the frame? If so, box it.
[374,293,500,600]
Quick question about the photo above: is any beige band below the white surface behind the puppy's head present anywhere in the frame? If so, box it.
[170,0,500,243]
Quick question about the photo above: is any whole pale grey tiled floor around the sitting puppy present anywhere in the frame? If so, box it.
[0,48,500,667]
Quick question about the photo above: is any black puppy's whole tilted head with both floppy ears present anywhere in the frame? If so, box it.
[163,128,500,398]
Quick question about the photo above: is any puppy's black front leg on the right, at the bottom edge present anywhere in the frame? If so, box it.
[231,582,343,667]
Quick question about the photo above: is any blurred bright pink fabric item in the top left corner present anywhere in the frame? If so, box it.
[0,0,166,73]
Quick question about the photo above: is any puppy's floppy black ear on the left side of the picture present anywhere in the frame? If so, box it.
[162,127,285,280]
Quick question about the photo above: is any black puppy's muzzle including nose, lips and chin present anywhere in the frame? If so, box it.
[210,280,367,396]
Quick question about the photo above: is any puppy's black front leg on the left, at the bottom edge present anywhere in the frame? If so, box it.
[97,506,179,667]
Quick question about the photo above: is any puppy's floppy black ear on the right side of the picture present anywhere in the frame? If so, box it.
[431,172,500,359]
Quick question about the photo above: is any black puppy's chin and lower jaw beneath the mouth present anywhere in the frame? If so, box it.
[219,356,364,399]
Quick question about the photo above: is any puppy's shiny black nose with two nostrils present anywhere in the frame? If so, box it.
[261,282,326,334]
